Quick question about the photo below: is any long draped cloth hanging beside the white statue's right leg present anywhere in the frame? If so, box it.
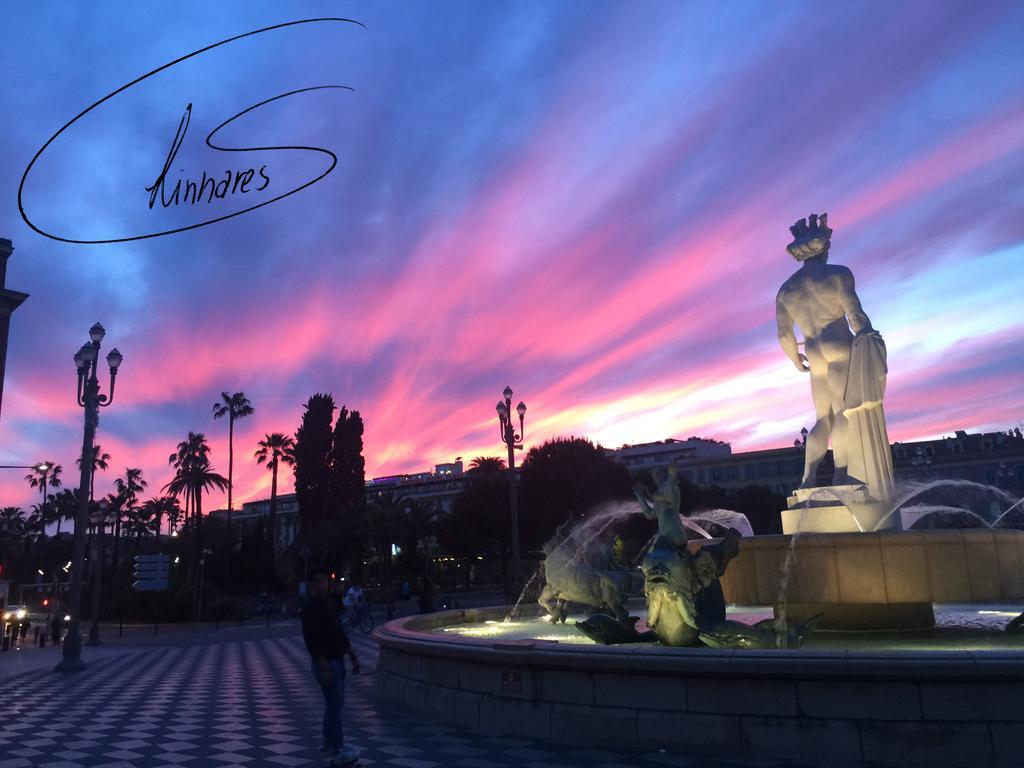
[844,333,893,501]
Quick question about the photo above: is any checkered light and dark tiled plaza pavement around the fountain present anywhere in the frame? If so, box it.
[0,631,851,768]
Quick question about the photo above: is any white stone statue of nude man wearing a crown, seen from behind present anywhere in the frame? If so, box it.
[775,213,892,498]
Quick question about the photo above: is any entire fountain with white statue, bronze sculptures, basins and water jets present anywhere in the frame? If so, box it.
[375,215,1024,766]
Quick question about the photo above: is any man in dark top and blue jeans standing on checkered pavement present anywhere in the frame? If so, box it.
[302,568,359,766]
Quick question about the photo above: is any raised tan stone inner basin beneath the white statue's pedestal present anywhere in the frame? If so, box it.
[722,528,1024,631]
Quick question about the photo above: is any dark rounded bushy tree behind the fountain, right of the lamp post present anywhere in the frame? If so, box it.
[519,437,632,549]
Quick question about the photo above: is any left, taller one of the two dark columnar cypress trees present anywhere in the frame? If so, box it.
[295,394,335,530]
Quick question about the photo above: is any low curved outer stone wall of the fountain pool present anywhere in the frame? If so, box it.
[375,608,1024,766]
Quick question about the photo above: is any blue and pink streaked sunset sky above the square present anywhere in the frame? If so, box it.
[0,0,1024,509]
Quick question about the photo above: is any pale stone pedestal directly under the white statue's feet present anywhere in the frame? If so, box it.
[782,483,900,534]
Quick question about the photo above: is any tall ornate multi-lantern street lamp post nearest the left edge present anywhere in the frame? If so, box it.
[56,323,124,672]
